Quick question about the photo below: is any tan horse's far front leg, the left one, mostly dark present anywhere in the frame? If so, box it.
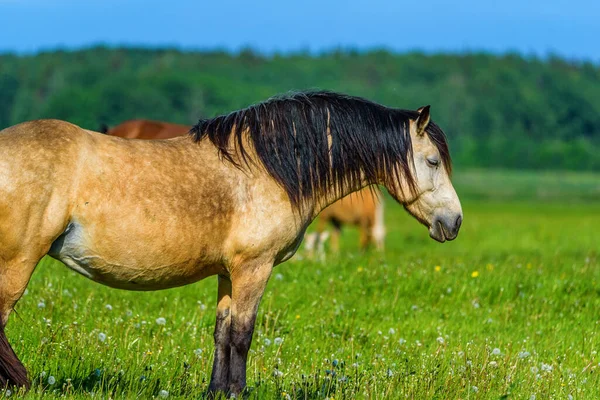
[208,275,231,394]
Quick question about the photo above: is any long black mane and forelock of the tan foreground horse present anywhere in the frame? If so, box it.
[190,91,451,207]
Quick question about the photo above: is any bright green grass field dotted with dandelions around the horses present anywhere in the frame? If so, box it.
[0,171,600,399]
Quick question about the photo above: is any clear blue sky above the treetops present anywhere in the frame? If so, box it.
[0,0,600,62]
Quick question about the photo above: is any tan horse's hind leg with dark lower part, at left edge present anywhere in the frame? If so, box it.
[0,261,37,389]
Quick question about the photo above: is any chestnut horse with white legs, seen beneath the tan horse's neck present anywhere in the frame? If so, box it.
[304,187,385,256]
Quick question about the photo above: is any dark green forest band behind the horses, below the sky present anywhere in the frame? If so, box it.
[0,47,600,171]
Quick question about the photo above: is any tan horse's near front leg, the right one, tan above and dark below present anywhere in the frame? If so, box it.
[229,263,273,395]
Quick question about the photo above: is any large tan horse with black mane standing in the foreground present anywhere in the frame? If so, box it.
[0,91,463,395]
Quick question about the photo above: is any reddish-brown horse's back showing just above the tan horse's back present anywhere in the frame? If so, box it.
[100,119,191,139]
